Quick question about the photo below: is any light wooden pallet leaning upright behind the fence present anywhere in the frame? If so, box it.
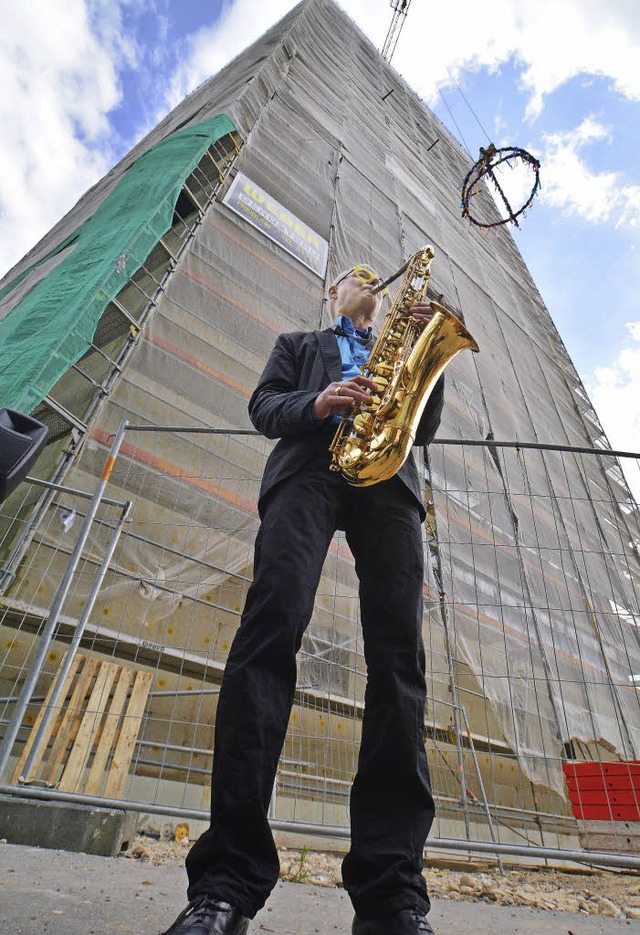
[11,654,152,798]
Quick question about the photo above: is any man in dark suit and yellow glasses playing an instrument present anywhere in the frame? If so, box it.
[165,264,444,935]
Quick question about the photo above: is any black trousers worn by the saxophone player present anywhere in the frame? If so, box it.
[187,455,434,918]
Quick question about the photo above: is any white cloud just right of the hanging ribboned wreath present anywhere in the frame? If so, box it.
[541,117,640,227]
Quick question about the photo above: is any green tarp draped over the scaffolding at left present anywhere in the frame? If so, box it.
[0,114,235,412]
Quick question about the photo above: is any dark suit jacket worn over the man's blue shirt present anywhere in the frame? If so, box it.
[249,328,444,519]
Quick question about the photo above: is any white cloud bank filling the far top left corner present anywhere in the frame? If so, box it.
[0,0,135,274]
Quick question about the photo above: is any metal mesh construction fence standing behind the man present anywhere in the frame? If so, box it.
[0,425,640,865]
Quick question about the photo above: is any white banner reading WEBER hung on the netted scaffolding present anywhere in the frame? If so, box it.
[223,172,329,279]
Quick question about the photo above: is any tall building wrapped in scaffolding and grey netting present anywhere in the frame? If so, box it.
[0,0,640,855]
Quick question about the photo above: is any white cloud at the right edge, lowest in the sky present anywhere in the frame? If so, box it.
[587,321,640,500]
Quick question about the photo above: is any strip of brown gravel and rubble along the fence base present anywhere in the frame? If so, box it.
[122,836,640,920]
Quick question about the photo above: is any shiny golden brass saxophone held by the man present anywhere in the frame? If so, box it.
[329,246,479,487]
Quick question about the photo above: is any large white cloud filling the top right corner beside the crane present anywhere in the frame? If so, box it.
[372,0,640,119]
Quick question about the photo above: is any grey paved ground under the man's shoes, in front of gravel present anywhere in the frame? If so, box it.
[0,844,640,935]
